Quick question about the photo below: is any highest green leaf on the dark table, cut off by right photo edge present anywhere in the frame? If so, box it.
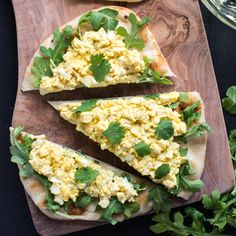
[222,86,236,115]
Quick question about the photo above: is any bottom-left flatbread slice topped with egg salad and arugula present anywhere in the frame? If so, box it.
[10,127,166,224]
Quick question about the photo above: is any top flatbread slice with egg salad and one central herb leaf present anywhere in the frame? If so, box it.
[22,6,174,95]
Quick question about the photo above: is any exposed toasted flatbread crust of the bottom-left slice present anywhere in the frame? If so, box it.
[10,131,155,221]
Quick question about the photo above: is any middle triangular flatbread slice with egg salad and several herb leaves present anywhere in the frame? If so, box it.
[49,92,210,199]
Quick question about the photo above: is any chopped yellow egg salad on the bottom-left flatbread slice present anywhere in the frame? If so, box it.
[29,139,138,208]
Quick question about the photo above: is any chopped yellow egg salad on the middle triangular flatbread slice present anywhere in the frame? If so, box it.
[59,92,186,189]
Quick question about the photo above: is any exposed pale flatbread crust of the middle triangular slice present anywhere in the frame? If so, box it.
[49,92,207,200]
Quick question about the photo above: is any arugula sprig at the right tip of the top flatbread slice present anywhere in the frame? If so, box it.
[140,56,173,85]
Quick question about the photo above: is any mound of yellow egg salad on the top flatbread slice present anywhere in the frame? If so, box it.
[40,28,145,94]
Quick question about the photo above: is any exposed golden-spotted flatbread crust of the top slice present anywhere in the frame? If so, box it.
[21,6,175,91]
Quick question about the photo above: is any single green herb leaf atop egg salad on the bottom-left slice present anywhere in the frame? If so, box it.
[75,167,99,183]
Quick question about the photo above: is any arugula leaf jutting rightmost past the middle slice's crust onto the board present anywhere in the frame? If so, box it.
[175,122,211,143]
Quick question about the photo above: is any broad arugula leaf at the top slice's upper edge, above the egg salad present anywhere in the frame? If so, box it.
[78,8,118,33]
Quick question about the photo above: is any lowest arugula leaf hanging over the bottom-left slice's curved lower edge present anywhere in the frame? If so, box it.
[101,198,124,225]
